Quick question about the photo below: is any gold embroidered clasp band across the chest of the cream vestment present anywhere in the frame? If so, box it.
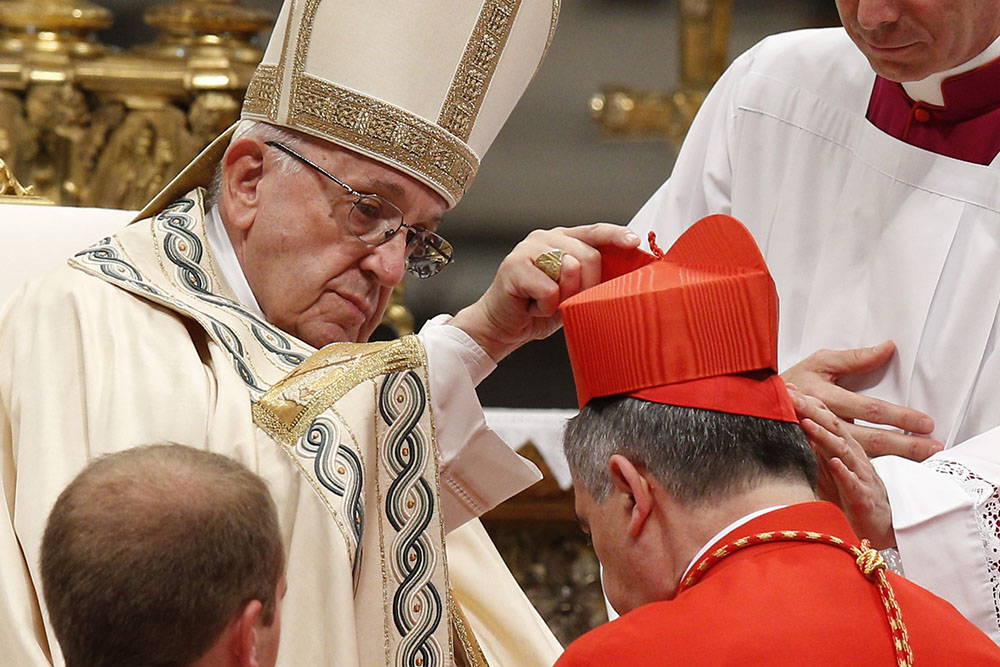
[253,336,422,445]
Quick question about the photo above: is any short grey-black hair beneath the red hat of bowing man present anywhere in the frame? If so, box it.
[563,396,816,506]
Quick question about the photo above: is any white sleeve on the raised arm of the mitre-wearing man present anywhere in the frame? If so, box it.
[418,315,542,532]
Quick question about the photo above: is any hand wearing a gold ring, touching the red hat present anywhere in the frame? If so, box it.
[451,222,639,361]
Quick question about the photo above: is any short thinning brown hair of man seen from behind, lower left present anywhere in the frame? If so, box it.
[41,445,285,667]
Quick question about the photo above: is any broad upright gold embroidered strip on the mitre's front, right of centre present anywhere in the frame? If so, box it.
[438,0,521,141]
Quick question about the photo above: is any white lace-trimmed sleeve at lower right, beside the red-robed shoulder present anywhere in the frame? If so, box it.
[873,429,1000,643]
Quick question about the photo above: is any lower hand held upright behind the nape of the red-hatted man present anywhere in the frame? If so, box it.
[788,386,896,549]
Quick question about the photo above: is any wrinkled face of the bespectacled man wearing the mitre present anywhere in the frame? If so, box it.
[241,140,447,348]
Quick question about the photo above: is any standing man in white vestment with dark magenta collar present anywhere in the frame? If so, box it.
[631,0,1000,641]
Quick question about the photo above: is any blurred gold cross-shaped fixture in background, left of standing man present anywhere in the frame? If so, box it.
[590,0,732,146]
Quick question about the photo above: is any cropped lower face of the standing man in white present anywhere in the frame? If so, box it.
[837,0,1000,81]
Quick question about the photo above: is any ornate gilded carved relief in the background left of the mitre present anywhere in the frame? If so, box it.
[0,0,273,209]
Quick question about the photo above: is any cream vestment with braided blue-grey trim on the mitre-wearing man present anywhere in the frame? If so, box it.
[0,191,560,666]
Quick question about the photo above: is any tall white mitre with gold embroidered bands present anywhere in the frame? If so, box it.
[140,0,560,217]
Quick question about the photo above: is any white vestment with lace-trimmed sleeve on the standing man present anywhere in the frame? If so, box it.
[631,28,1000,641]
